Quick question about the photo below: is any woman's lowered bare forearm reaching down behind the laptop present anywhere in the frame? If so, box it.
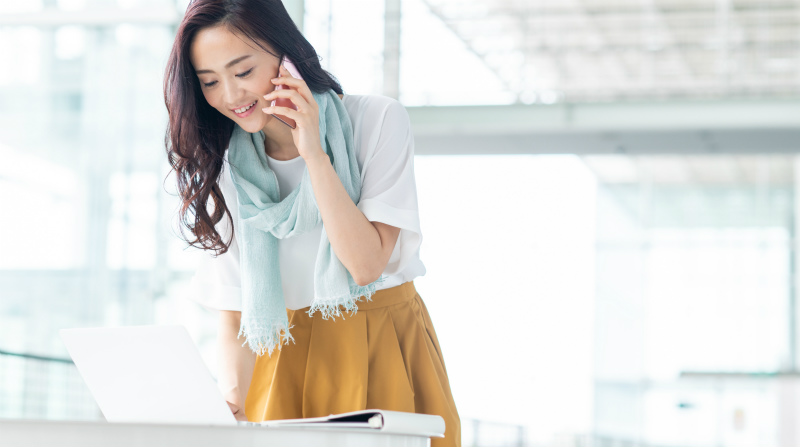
[217,310,256,421]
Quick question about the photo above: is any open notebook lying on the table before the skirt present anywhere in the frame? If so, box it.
[248,409,445,438]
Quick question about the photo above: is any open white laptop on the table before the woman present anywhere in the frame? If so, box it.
[59,325,238,426]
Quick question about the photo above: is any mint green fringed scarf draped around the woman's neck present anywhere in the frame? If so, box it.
[228,89,384,356]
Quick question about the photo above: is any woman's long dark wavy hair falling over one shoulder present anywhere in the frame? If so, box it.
[164,0,343,256]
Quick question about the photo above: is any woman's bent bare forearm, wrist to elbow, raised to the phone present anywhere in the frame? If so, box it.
[306,151,400,286]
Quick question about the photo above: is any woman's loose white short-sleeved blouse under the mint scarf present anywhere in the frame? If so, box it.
[188,95,426,311]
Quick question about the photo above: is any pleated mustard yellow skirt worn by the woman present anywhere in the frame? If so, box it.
[245,281,461,447]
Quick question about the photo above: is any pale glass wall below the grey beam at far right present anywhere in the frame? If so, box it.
[585,155,796,446]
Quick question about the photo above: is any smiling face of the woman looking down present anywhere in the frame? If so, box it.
[189,26,280,133]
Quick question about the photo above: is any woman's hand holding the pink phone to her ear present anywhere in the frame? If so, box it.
[261,65,328,161]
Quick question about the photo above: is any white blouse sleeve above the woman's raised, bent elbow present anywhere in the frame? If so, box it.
[357,97,422,275]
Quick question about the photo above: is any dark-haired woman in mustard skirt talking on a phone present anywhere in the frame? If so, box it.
[164,0,461,447]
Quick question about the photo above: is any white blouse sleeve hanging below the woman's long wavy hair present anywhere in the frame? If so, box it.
[189,163,242,311]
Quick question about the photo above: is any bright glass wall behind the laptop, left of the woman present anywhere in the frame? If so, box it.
[0,2,205,419]
